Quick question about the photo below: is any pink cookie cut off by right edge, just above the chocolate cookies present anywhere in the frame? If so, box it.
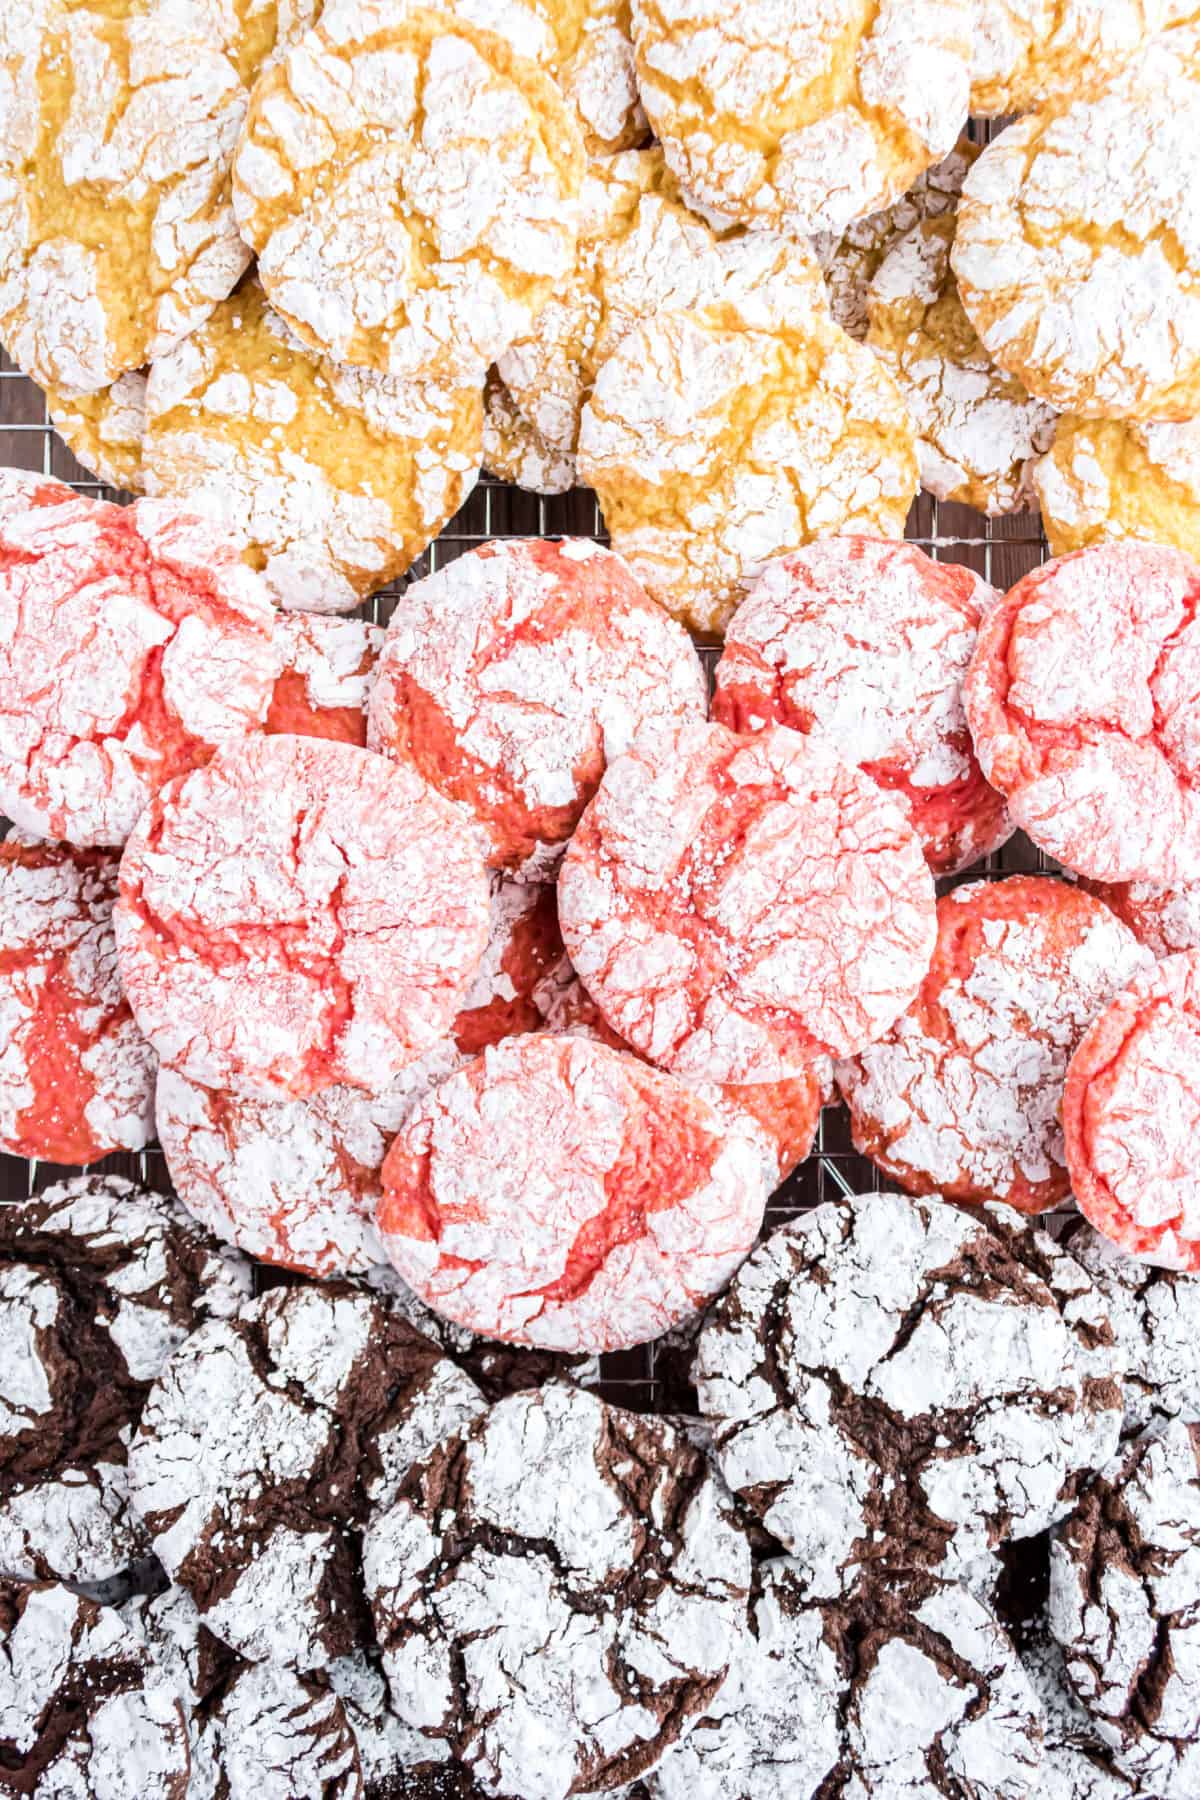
[1063,950,1200,1271]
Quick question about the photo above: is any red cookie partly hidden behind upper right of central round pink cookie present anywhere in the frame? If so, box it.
[712,536,1011,875]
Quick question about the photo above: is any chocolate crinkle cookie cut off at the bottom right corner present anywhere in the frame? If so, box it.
[1047,1418,1200,1800]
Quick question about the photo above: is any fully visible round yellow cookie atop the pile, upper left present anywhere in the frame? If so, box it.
[234,0,583,383]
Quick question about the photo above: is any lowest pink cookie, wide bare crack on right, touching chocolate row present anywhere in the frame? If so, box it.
[376,1035,766,1352]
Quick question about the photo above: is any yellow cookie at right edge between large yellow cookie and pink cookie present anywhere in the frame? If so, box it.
[1036,414,1200,556]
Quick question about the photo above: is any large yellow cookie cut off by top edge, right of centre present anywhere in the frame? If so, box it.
[633,0,972,236]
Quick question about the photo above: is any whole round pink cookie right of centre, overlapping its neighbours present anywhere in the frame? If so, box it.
[558,724,936,1085]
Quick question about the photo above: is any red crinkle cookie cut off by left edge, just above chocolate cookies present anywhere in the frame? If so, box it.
[0,837,157,1163]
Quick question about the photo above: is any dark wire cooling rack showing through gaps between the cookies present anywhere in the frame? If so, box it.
[0,338,1049,1411]
